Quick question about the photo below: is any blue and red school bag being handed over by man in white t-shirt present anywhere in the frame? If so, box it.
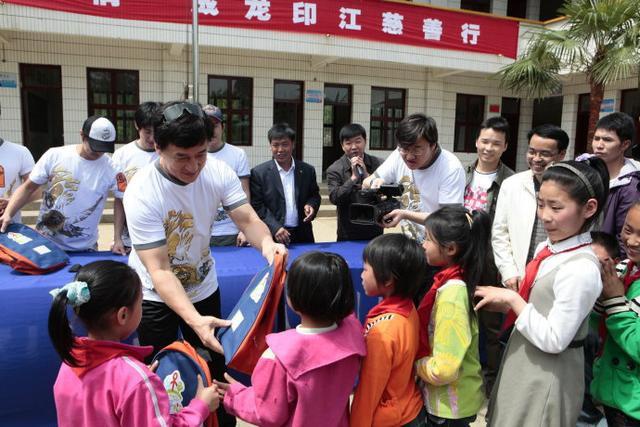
[217,254,286,375]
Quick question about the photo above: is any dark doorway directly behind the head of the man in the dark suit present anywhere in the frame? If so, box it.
[273,80,304,160]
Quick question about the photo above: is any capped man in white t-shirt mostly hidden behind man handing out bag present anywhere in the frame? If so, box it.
[202,104,251,246]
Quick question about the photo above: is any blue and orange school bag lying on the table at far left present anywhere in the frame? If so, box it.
[0,224,69,274]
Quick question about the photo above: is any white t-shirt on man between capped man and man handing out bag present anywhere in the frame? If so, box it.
[111,141,158,246]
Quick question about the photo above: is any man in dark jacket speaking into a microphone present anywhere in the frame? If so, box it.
[327,123,382,242]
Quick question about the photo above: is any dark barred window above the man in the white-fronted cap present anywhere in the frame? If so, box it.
[87,68,140,144]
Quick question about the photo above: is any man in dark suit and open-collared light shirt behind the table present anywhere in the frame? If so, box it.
[250,123,320,244]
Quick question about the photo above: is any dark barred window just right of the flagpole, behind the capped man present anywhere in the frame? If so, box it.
[207,76,253,145]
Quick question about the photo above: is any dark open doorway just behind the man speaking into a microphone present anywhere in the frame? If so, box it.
[322,84,351,178]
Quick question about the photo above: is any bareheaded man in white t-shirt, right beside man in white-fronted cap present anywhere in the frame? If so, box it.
[111,102,162,255]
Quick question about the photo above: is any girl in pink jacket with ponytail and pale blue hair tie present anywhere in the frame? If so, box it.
[49,261,218,427]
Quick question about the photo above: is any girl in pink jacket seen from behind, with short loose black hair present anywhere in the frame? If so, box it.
[218,252,366,427]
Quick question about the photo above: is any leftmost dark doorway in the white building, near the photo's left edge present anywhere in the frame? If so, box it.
[20,64,64,161]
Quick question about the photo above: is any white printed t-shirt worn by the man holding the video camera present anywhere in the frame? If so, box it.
[375,149,466,242]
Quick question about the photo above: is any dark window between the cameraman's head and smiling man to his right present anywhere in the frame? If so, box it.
[454,93,484,153]
